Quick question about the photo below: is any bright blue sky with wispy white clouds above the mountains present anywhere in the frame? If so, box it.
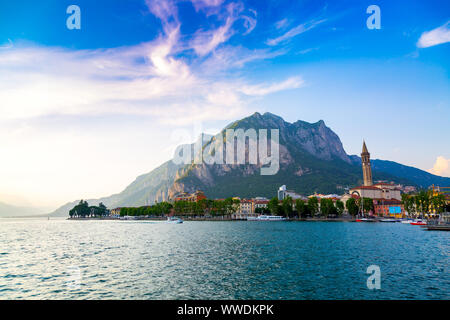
[0,0,450,206]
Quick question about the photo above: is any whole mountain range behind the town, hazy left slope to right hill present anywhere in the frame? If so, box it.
[52,113,450,216]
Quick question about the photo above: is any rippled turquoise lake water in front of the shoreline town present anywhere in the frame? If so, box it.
[0,219,450,299]
